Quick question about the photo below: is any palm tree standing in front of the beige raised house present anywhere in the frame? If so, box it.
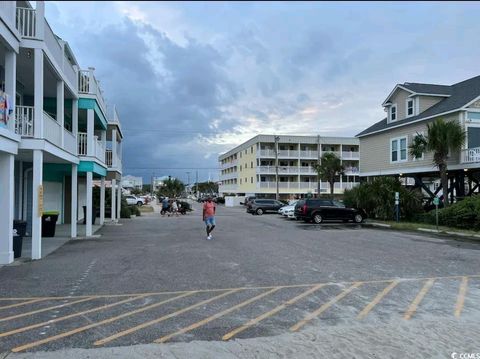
[409,119,466,206]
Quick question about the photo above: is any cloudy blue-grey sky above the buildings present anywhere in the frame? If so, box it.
[46,2,480,182]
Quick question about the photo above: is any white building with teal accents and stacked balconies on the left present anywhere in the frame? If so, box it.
[0,1,123,264]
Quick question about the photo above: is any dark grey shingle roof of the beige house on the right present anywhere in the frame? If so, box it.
[357,76,480,137]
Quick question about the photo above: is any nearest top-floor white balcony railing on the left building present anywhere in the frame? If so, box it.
[15,7,77,89]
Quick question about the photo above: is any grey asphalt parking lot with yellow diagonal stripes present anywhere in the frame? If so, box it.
[0,204,480,353]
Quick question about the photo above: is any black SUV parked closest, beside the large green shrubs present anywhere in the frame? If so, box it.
[294,198,365,224]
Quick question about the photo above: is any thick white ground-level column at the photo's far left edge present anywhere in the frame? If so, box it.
[0,153,15,264]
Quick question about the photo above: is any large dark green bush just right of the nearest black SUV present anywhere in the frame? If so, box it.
[343,177,423,220]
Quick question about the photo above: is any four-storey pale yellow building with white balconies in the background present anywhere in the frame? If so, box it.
[219,135,360,199]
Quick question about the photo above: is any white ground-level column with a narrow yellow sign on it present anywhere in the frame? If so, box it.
[32,150,43,259]
